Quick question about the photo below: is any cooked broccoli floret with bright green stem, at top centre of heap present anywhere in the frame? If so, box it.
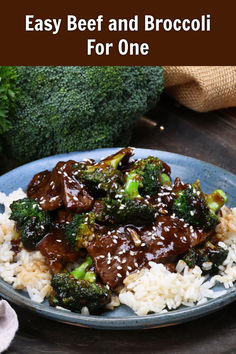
[125,156,171,198]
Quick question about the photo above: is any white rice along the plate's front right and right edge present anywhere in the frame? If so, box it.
[119,207,236,316]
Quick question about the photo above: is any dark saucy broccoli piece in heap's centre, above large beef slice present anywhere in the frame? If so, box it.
[96,195,156,225]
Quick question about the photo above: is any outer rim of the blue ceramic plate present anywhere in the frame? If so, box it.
[0,147,236,330]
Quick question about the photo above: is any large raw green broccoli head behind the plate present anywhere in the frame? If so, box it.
[4,66,164,162]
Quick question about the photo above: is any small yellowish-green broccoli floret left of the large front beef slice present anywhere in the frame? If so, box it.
[65,212,95,249]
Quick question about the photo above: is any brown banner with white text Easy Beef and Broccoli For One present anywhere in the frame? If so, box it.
[0,0,236,65]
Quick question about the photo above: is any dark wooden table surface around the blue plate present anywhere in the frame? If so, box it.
[0,96,236,354]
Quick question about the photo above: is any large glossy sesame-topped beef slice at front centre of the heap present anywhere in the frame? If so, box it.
[88,215,208,289]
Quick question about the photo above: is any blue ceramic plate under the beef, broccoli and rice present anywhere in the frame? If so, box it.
[0,149,236,329]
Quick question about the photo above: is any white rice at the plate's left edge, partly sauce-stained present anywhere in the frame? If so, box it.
[0,188,51,303]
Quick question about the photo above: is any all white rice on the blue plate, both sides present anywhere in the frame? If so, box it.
[0,189,236,315]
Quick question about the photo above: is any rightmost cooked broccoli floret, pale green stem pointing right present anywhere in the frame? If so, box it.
[172,180,227,231]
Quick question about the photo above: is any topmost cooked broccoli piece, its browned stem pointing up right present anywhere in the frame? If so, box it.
[77,148,133,194]
